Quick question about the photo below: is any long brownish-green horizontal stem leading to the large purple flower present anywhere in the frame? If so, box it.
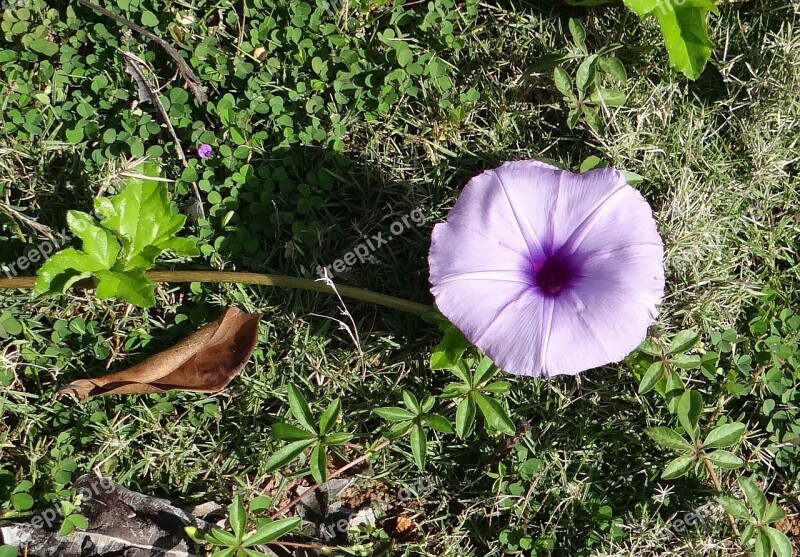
[0,271,433,315]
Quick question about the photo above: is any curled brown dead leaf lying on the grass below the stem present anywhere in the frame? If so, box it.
[58,308,261,402]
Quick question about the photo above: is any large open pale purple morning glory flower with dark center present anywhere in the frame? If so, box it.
[429,161,664,376]
